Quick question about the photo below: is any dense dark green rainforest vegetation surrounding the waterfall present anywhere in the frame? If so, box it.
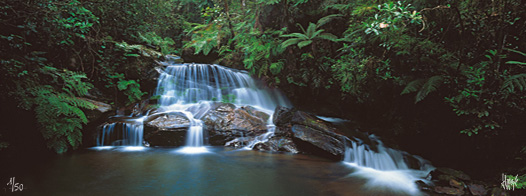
[0,0,526,180]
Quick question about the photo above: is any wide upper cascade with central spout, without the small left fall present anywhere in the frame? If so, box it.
[156,62,290,152]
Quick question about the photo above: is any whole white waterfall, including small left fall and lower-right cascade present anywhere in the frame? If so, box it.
[92,59,442,195]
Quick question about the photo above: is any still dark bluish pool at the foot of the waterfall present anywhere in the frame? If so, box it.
[2,147,424,196]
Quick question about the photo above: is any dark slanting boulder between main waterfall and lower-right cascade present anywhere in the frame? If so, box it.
[273,107,348,160]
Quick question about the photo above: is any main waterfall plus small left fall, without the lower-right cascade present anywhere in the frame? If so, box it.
[97,60,291,152]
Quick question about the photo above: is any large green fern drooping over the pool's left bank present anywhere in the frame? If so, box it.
[17,66,96,154]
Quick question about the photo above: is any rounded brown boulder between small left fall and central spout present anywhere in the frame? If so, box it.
[144,112,190,146]
